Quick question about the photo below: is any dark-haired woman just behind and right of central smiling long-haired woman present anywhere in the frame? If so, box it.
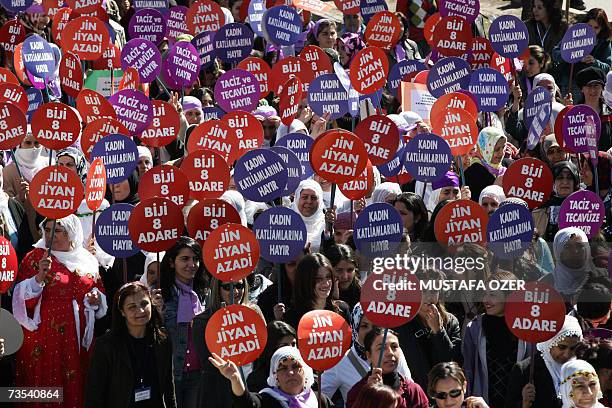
[325,244,361,309]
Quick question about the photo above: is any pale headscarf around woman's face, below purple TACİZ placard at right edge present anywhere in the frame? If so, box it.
[553,227,591,296]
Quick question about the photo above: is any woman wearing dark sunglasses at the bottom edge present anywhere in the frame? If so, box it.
[427,361,489,408]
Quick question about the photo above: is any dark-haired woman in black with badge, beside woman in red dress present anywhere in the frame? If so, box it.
[84,282,176,408]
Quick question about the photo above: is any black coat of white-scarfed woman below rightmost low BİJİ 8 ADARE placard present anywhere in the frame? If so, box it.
[504,352,561,408]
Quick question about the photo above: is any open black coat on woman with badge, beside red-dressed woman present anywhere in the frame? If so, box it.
[84,332,176,408]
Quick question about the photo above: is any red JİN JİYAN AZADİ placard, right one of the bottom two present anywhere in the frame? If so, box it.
[297,310,351,371]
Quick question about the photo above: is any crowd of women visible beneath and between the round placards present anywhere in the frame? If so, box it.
[0,0,612,408]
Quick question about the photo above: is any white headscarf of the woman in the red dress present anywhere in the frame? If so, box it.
[34,214,99,281]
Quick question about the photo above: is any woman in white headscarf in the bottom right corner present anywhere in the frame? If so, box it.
[559,360,605,408]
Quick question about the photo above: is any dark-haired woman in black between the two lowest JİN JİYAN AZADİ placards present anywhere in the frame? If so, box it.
[247,320,297,392]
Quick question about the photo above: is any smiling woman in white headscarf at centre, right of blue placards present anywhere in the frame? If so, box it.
[291,179,325,252]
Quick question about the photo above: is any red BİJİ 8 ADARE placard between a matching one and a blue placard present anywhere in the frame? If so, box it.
[181,149,230,200]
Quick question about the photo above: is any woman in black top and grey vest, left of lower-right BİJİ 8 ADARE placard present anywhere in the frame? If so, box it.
[461,272,528,407]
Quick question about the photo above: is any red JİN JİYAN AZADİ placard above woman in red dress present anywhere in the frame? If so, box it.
[29,166,83,219]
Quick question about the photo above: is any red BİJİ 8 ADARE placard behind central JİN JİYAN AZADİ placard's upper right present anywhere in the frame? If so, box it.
[355,115,399,166]
